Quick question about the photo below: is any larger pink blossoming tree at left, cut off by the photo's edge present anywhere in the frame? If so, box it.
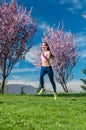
[0,0,36,93]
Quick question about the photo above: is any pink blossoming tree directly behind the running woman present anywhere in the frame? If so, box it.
[35,27,78,92]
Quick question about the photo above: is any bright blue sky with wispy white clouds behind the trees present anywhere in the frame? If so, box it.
[8,0,86,81]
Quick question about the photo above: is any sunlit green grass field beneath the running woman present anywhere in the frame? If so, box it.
[0,93,86,130]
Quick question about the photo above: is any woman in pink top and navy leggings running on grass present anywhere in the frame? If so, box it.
[38,42,56,100]
